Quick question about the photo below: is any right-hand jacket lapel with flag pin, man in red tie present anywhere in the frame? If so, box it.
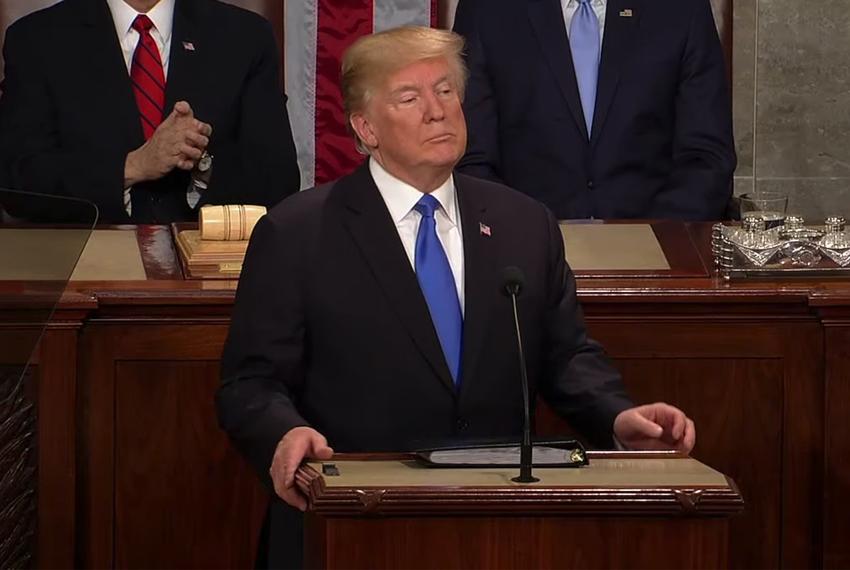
[165,0,201,113]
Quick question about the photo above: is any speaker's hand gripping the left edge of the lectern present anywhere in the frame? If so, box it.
[269,426,333,511]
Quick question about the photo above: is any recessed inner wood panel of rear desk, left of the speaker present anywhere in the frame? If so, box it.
[112,362,267,568]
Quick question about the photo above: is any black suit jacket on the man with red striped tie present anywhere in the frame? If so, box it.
[0,0,300,223]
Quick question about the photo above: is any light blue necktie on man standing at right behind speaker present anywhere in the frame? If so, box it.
[570,0,600,137]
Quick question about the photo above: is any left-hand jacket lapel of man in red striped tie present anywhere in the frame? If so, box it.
[79,0,144,150]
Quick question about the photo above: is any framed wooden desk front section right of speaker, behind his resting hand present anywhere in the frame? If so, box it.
[538,315,823,568]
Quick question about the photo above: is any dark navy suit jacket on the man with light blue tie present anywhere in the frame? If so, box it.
[455,0,735,219]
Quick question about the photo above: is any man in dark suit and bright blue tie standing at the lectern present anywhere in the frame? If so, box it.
[217,28,694,564]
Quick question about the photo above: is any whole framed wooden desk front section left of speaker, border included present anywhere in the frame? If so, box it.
[81,322,268,568]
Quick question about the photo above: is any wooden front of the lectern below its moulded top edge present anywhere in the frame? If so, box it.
[306,517,728,570]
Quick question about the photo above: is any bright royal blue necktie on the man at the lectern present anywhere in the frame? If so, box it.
[413,194,463,384]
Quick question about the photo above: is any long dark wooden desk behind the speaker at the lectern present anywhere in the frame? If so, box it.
[1,222,850,568]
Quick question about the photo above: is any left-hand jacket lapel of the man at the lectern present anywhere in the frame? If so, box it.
[335,163,455,393]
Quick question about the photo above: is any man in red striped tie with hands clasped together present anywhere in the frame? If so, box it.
[0,0,300,223]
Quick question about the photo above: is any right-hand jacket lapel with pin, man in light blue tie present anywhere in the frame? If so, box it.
[590,0,642,146]
